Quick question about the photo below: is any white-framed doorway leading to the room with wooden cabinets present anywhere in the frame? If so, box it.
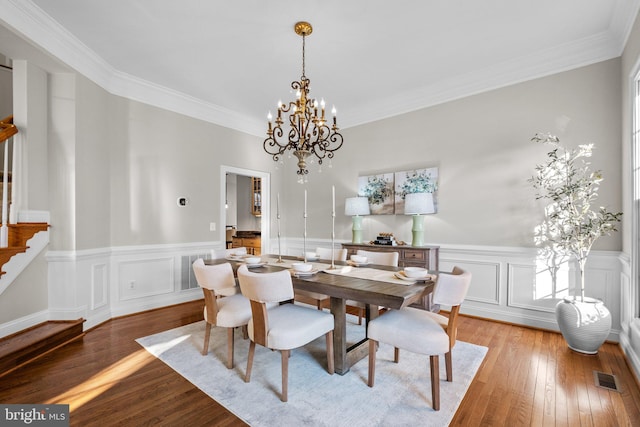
[220,165,271,254]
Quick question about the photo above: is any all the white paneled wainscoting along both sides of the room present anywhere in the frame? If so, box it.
[10,238,624,344]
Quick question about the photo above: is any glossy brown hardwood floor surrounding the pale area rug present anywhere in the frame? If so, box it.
[0,301,640,427]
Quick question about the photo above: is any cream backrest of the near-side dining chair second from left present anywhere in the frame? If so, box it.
[238,265,294,303]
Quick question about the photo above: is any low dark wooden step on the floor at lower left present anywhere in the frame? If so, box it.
[0,319,84,377]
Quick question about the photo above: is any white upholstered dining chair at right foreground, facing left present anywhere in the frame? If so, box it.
[367,267,471,411]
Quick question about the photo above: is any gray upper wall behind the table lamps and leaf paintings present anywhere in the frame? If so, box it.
[282,59,623,250]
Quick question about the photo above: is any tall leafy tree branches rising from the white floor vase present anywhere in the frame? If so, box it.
[529,133,622,300]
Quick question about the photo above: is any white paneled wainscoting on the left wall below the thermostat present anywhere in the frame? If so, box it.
[46,242,224,329]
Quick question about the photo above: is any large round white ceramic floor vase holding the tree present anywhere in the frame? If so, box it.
[556,297,611,354]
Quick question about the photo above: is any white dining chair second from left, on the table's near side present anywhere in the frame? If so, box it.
[238,265,334,402]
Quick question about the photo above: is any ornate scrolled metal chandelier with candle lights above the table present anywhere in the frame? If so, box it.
[263,22,343,178]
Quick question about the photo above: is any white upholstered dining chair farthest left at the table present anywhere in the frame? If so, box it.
[193,258,251,369]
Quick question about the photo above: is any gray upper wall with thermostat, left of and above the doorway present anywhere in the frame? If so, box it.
[110,98,274,246]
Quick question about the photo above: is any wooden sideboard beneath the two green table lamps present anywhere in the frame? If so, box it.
[342,243,440,312]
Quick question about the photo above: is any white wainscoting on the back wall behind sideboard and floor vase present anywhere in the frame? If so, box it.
[284,239,624,342]
